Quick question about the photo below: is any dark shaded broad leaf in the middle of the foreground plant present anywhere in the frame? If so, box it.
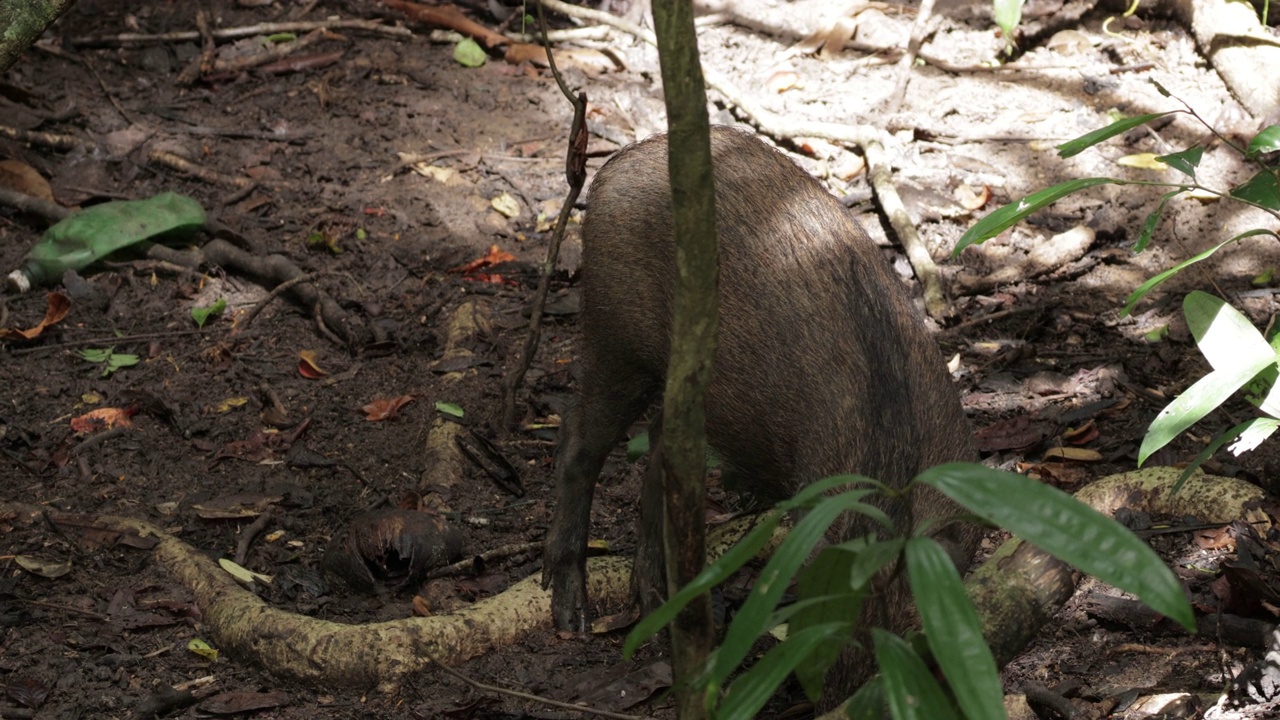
[787,546,867,700]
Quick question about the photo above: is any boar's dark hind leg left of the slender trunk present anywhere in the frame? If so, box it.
[543,361,659,632]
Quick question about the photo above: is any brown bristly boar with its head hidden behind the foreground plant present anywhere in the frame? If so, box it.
[543,127,978,702]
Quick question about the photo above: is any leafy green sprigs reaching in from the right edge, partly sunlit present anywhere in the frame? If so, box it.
[955,83,1280,477]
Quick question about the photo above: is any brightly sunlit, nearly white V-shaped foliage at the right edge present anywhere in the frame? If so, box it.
[1138,291,1276,465]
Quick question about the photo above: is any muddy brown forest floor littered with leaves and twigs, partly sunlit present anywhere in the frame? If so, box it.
[0,0,1280,719]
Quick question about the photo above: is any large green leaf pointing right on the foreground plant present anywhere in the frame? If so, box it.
[915,462,1196,630]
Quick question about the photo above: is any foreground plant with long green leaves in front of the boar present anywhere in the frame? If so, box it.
[626,462,1194,720]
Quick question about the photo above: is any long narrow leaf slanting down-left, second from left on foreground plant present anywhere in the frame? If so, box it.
[710,489,887,687]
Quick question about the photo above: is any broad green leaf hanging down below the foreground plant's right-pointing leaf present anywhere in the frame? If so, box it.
[906,537,1006,720]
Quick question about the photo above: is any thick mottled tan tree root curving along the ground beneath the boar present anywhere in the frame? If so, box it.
[0,468,1271,702]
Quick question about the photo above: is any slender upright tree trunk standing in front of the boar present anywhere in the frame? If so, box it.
[653,0,719,720]
